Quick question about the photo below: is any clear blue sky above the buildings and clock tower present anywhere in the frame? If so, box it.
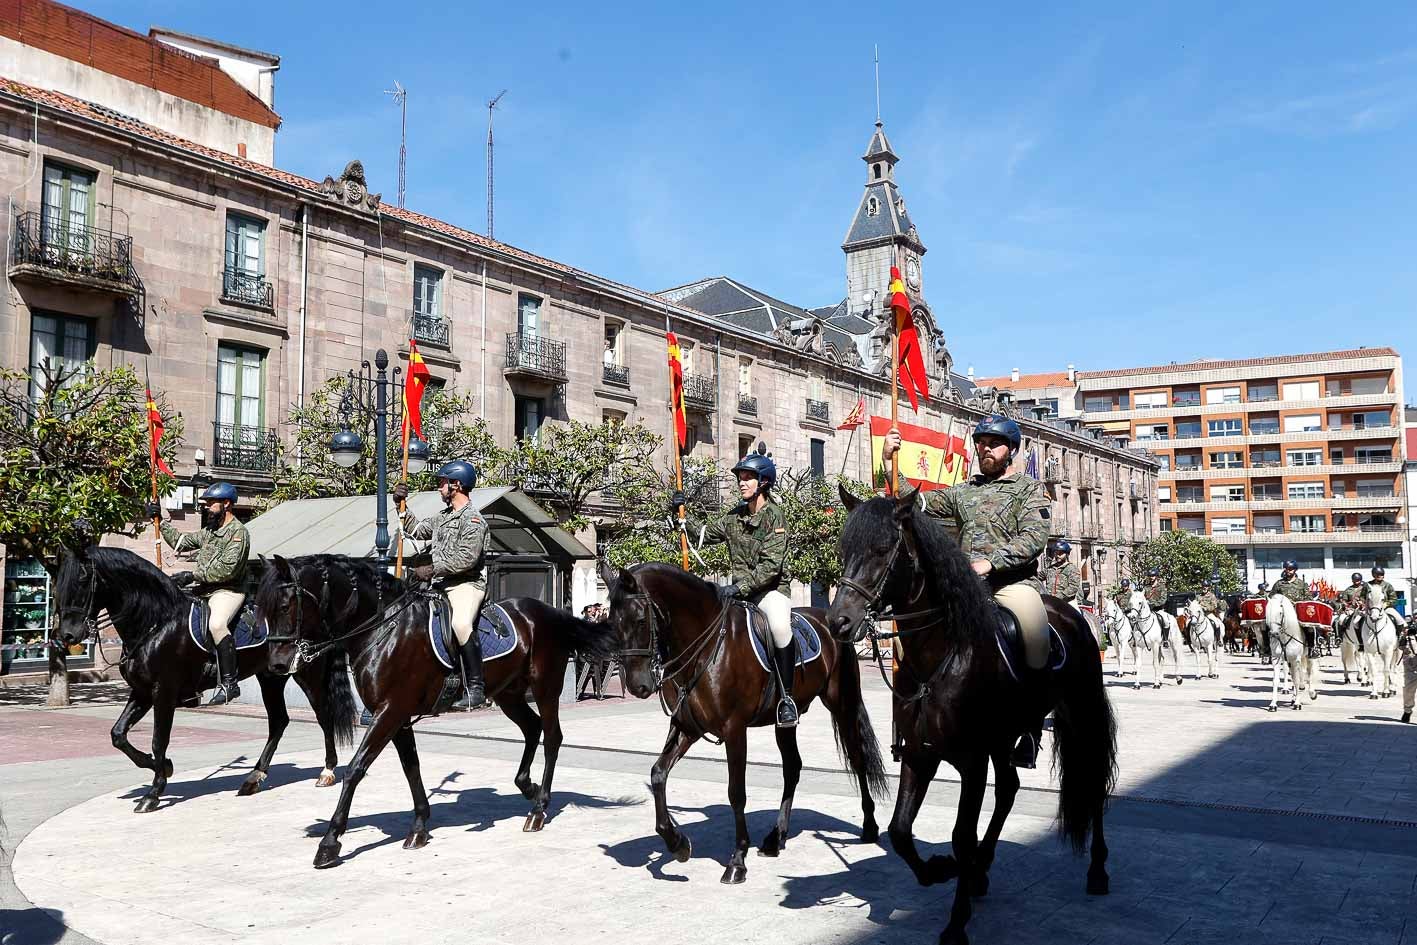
[91,0,1417,374]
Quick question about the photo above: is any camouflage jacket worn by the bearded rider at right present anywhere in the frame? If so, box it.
[922,473,1051,591]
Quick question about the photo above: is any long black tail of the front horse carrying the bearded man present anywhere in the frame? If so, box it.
[1053,646,1117,853]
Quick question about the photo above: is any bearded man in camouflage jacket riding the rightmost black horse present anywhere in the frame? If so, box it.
[883,415,1053,768]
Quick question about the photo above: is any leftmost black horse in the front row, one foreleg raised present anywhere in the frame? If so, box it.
[55,545,354,813]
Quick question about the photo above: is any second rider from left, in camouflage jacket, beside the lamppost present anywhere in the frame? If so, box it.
[393,459,492,711]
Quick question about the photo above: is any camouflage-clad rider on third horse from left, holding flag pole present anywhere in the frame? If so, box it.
[670,453,798,728]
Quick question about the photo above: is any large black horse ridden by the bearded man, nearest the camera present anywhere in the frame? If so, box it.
[828,489,1117,944]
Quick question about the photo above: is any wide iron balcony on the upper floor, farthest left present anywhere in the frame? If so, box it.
[10,210,143,302]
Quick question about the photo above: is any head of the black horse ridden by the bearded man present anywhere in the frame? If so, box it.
[826,485,915,643]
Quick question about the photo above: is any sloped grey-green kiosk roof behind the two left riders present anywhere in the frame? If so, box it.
[247,486,595,561]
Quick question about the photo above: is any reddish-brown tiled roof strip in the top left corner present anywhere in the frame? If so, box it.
[0,0,281,128]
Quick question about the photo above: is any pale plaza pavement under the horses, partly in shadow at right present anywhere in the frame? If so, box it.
[0,657,1417,945]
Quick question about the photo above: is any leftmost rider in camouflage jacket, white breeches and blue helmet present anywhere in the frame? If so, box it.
[147,482,251,706]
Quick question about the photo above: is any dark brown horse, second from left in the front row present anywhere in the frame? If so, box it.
[256,554,614,868]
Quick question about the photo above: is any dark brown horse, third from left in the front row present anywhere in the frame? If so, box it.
[601,562,886,883]
